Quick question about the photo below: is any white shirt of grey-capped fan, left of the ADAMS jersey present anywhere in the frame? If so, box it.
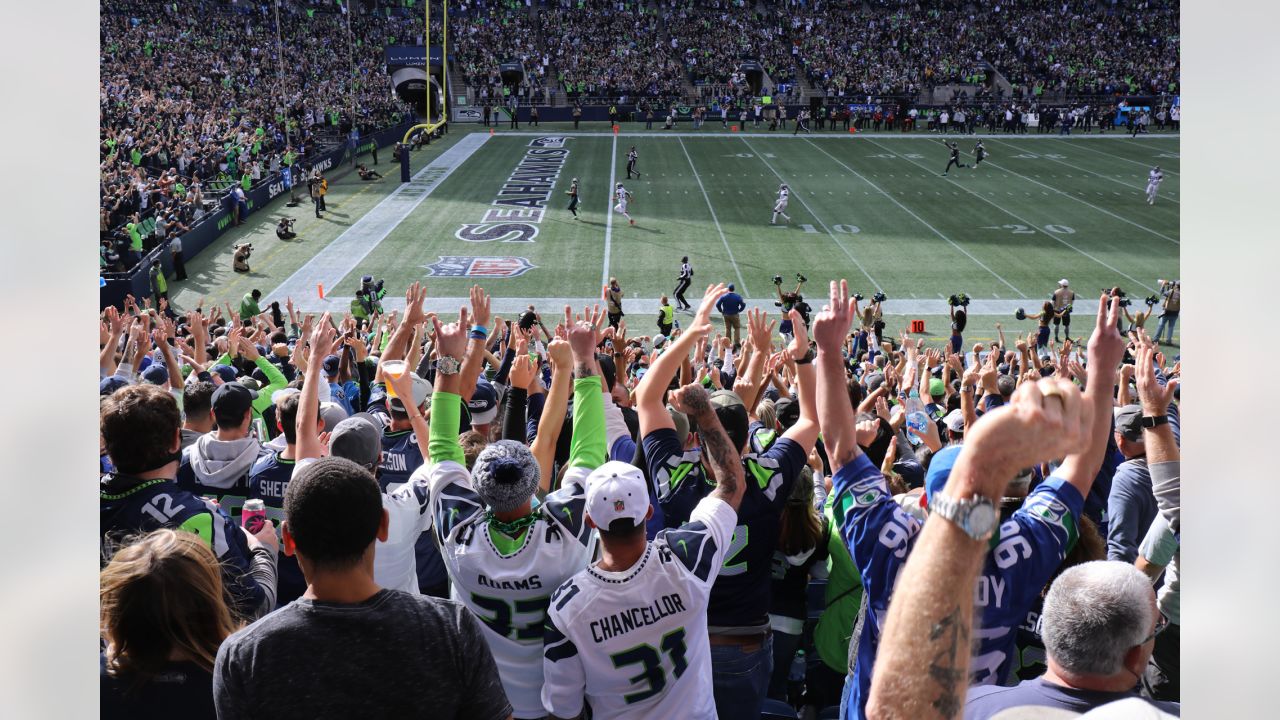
[291,457,431,594]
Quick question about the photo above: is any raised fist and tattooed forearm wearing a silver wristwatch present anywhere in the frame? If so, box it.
[867,371,1095,719]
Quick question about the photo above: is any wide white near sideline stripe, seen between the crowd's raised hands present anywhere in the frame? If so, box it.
[294,293,1080,315]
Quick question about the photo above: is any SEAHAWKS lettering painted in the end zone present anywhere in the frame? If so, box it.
[453,136,570,244]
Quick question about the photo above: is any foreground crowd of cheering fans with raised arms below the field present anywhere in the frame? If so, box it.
[100,270,1180,719]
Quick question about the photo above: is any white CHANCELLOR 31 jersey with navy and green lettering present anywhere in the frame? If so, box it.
[543,496,737,720]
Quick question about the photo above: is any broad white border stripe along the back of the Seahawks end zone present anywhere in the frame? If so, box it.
[268,132,493,299]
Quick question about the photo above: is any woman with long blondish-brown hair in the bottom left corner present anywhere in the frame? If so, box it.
[99,529,238,720]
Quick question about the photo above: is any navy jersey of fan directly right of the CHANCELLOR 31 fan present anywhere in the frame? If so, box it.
[643,428,805,632]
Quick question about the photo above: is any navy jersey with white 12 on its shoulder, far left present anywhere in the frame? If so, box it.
[99,475,266,616]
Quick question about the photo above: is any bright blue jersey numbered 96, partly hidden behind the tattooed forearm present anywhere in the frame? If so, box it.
[832,455,1084,717]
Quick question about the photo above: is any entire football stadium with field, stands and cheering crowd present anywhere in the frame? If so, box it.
[99,0,1183,720]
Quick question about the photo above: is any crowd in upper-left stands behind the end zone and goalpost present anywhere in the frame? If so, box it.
[99,0,421,269]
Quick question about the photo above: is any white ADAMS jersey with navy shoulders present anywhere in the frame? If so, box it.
[424,460,591,717]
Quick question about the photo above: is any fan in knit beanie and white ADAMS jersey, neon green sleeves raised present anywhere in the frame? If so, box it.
[415,302,605,719]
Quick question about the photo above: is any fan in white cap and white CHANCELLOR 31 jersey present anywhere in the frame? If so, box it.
[543,323,744,720]
